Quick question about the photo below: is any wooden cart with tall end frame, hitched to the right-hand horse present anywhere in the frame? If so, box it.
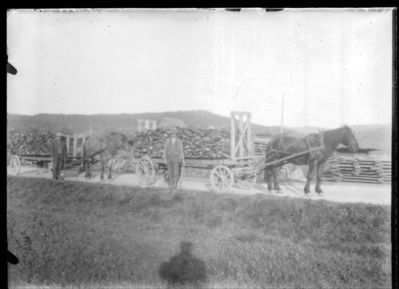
[136,112,319,192]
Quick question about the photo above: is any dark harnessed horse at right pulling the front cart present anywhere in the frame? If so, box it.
[264,125,359,194]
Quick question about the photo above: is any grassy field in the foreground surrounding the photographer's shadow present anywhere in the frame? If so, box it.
[7,177,391,288]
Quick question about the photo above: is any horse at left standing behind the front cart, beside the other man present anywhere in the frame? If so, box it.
[82,132,132,180]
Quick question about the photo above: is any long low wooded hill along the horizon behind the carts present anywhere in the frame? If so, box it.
[7,110,392,155]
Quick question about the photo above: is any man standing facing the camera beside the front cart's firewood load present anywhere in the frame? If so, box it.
[163,128,184,193]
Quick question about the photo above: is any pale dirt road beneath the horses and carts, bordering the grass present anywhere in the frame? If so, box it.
[8,167,391,205]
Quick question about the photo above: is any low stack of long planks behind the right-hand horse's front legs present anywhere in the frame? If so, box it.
[323,157,391,183]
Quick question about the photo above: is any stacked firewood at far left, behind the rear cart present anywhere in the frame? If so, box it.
[7,133,54,156]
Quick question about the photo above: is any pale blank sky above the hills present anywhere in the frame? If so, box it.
[7,9,392,127]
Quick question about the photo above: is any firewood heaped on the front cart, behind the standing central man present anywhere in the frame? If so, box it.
[133,128,230,159]
